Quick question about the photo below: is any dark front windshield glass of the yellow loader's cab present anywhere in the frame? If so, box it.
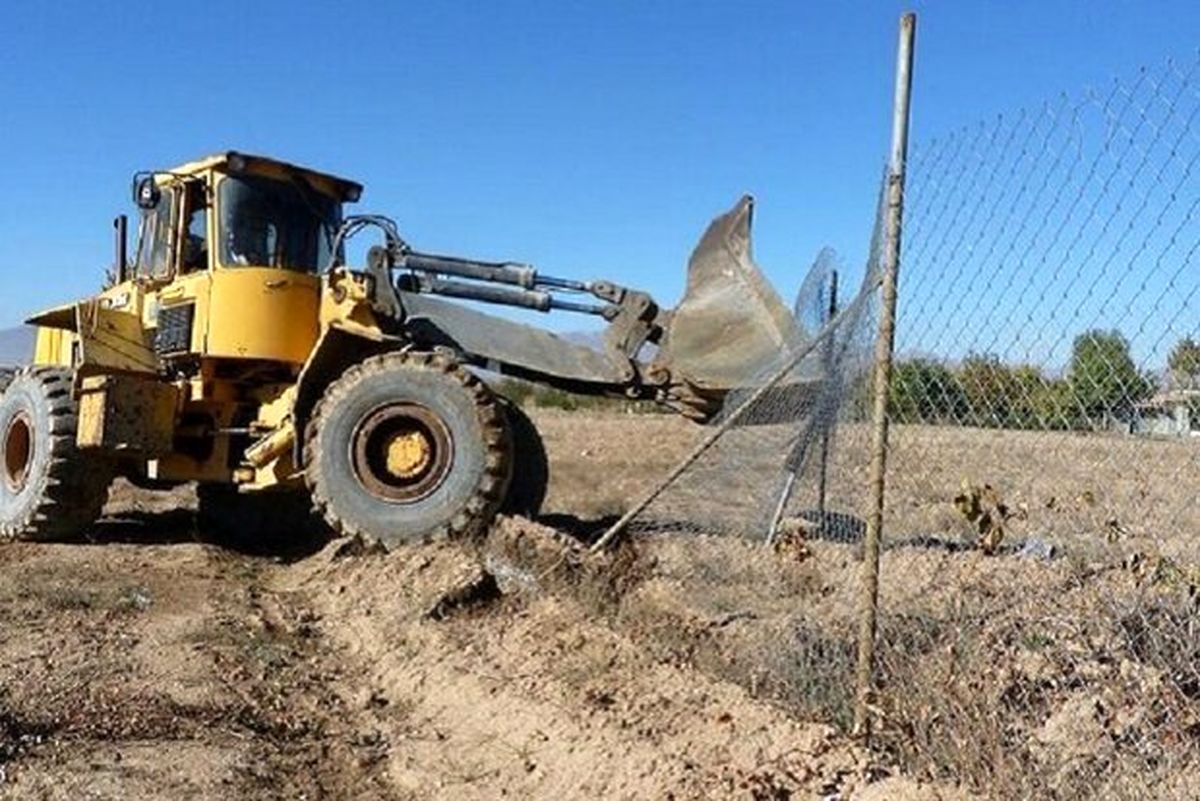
[220,175,342,272]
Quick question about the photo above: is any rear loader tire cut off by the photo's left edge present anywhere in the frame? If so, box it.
[0,367,113,540]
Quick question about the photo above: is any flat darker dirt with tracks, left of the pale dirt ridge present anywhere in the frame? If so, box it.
[0,532,396,800]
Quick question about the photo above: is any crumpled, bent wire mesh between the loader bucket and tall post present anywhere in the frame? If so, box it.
[629,193,878,542]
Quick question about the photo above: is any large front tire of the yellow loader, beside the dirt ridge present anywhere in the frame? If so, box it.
[305,353,512,549]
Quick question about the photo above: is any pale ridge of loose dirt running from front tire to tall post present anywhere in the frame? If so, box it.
[285,520,883,799]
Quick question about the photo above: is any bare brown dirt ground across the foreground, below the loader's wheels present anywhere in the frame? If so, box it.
[0,474,984,801]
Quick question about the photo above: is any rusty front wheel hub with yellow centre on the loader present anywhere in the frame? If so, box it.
[350,403,454,504]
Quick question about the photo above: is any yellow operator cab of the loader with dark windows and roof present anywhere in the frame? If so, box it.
[109,152,361,369]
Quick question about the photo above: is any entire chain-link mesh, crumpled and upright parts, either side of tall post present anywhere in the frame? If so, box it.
[614,58,1200,799]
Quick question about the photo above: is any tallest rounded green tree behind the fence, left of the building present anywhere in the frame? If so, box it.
[1067,329,1154,424]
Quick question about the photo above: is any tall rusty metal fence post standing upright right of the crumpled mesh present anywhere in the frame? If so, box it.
[854,13,917,741]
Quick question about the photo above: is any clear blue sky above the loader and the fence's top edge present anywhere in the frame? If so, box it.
[0,0,1200,340]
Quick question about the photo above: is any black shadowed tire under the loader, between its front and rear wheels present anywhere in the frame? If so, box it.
[196,484,328,553]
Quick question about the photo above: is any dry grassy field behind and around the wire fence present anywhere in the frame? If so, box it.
[539,414,1200,799]
